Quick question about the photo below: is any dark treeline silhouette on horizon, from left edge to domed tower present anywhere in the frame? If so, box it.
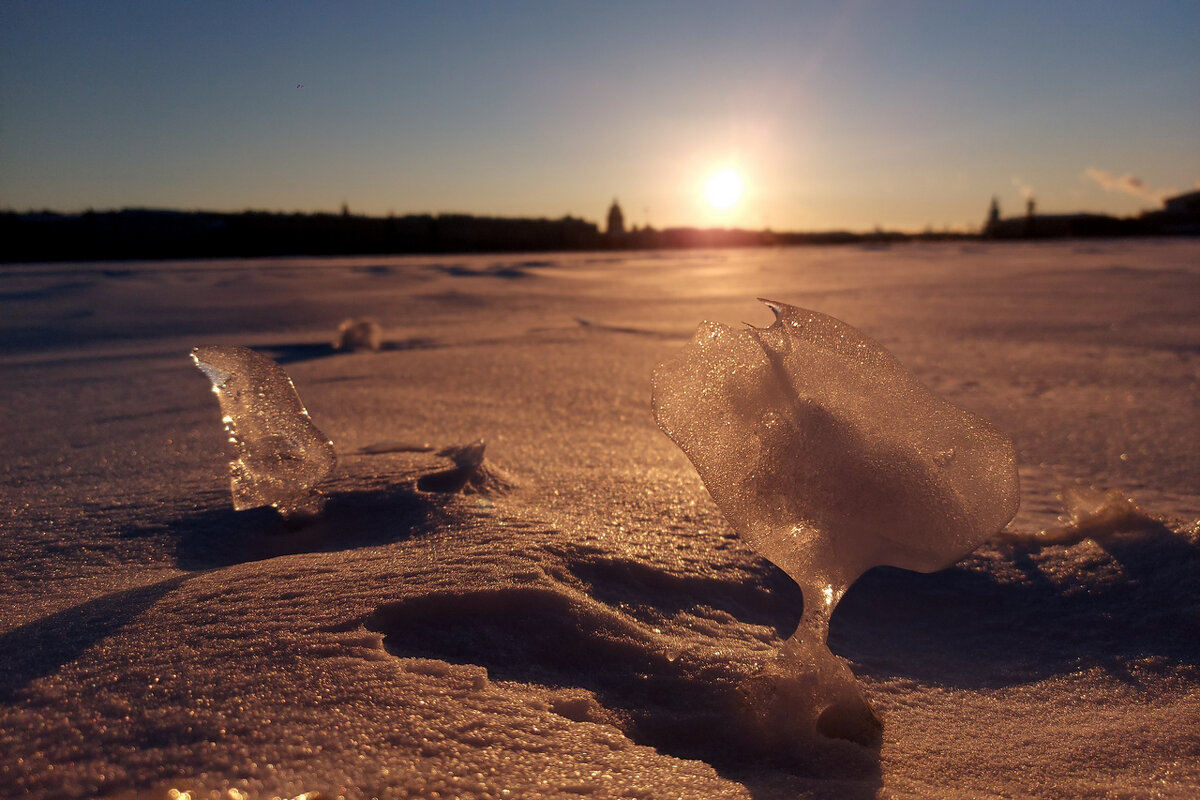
[0,209,601,261]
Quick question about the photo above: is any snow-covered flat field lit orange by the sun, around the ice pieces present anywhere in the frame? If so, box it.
[0,241,1200,800]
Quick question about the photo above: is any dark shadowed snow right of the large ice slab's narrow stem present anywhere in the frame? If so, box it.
[829,529,1200,688]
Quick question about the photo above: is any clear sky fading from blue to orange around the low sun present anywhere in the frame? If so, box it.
[0,0,1200,230]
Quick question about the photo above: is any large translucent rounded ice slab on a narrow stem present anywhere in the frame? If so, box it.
[653,300,1019,744]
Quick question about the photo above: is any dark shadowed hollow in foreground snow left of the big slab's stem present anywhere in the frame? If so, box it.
[365,557,880,798]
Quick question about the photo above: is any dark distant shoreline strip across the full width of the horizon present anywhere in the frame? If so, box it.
[0,209,1200,263]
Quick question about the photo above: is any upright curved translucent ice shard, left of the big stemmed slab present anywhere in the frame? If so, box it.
[192,345,337,517]
